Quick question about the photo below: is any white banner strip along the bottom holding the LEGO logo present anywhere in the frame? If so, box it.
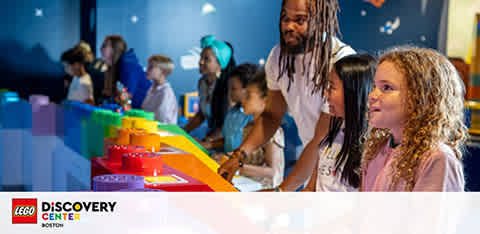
[0,192,480,234]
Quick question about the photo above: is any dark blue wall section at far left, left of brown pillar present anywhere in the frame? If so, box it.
[0,0,80,100]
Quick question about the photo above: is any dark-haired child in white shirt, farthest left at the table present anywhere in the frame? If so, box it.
[61,48,95,104]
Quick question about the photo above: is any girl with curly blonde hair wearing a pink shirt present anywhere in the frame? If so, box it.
[361,48,467,191]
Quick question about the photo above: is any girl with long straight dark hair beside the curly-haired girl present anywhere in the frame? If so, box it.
[305,55,376,192]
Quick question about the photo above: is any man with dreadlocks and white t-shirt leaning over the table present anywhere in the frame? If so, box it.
[218,0,355,191]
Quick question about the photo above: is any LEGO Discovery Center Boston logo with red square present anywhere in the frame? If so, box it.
[12,198,117,228]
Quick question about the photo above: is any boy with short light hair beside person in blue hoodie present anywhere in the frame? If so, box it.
[142,55,178,124]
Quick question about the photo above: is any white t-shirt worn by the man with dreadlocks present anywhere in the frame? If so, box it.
[265,38,355,147]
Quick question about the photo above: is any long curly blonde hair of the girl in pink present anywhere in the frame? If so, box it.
[362,47,468,191]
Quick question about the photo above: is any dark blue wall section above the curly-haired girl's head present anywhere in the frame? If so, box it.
[339,0,448,53]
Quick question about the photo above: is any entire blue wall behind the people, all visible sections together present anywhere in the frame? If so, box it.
[0,0,447,101]
